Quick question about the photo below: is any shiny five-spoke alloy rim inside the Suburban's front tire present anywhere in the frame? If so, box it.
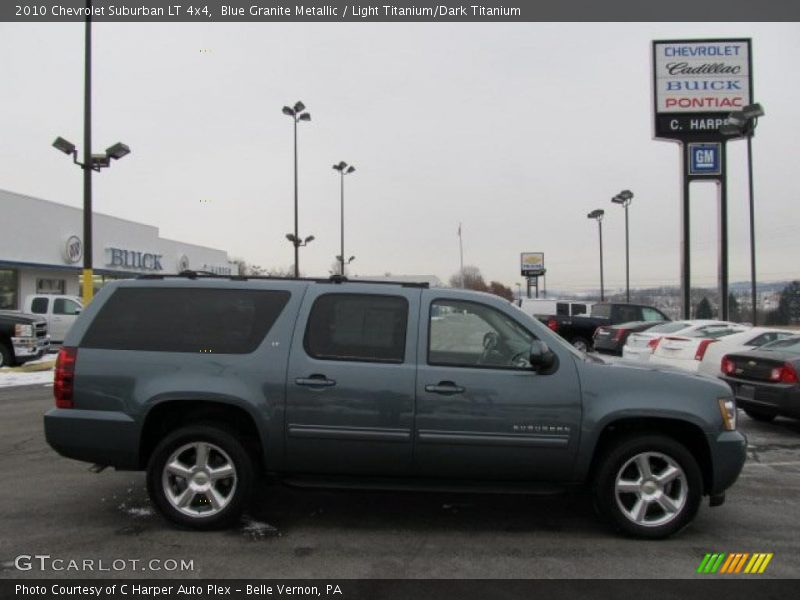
[614,452,689,527]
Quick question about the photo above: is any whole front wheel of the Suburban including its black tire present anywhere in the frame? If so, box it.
[594,433,703,539]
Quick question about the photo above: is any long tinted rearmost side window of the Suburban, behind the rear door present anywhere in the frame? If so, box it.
[81,288,290,354]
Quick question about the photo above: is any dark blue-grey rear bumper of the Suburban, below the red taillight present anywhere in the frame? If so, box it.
[44,408,141,469]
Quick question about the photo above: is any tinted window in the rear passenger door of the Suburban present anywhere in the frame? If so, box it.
[304,294,408,363]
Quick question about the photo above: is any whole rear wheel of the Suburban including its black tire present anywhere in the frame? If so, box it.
[147,424,255,530]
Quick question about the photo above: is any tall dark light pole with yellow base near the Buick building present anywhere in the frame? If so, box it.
[53,0,131,306]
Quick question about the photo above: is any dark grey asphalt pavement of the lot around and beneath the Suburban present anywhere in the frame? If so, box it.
[0,385,800,578]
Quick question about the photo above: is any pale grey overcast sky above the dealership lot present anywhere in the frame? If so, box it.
[0,23,800,291]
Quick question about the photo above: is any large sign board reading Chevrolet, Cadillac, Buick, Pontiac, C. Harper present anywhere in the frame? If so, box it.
[653,39,753,139]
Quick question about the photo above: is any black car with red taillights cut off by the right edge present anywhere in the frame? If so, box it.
[720,335,800,421]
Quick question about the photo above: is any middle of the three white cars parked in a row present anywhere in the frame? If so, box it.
[650,321,752,373]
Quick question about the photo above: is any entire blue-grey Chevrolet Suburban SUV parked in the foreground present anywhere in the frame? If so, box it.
[44,274,746,538]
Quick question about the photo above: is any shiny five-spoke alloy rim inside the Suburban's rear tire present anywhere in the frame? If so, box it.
[161,442,237,518]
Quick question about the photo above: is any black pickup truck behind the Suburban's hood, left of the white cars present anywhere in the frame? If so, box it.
[539,302,670,352]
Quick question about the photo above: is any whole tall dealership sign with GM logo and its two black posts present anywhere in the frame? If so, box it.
[653,39,753,319]
